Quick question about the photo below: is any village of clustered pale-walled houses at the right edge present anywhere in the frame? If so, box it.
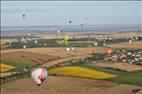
[105,49,142,65]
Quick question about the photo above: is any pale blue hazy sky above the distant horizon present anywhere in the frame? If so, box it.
[1,1,142,26]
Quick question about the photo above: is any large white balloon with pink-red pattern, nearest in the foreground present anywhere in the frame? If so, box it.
[31,68,48,86]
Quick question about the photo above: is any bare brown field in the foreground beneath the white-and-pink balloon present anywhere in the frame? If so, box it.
[1,76,142,94]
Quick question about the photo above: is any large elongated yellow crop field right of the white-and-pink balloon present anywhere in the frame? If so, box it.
[49,66,117,79]
